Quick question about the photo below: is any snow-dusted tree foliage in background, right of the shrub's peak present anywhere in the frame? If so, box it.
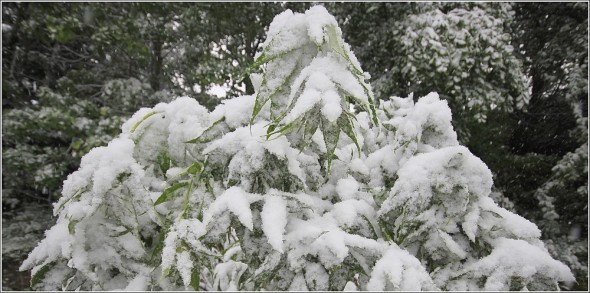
[343,3,529,143]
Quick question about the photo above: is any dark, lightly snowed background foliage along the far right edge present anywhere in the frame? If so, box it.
[512,3,588,290]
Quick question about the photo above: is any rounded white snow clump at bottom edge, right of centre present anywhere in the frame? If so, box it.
[367,244,437,291]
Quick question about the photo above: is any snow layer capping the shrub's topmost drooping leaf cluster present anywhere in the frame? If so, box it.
[254,6,371,130]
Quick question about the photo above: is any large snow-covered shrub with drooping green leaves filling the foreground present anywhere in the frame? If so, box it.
[21,6,573,290]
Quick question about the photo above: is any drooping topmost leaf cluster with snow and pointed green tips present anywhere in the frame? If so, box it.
[250,6,377,170]
